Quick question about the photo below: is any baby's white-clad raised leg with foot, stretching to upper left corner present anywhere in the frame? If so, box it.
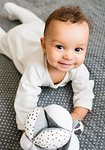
[4,2,44,26]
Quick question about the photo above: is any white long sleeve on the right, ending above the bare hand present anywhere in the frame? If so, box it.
[72,64,94,110]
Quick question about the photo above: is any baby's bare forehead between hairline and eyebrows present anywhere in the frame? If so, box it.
[45,20,89,46]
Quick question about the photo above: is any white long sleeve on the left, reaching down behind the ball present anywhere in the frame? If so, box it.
[14,66,41,130]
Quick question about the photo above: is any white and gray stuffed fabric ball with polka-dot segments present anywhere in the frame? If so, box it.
[20,104,83,150]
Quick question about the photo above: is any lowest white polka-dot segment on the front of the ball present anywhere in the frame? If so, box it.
[33,128,71,149]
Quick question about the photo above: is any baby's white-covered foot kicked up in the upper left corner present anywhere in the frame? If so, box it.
[4,2,20,21]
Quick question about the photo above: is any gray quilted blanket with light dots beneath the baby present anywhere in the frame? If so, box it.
[0,0,105,150]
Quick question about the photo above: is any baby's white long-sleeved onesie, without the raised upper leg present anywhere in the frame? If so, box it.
[0,22,94,130]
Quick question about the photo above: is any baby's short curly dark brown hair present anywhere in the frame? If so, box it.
[44,6,91,35]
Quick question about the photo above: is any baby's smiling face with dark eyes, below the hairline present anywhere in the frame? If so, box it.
[41,20,89,72]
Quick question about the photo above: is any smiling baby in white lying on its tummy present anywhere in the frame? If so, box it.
[0,2,94,139]
